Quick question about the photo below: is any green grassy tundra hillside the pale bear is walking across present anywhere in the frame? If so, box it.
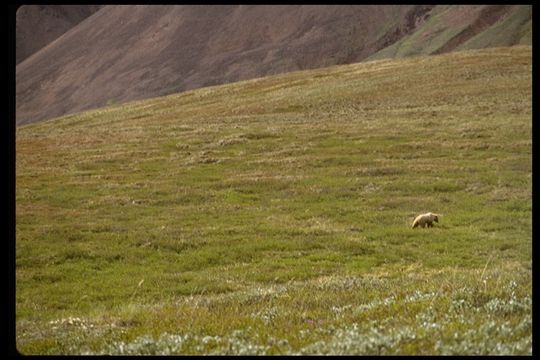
[16,47,532,354]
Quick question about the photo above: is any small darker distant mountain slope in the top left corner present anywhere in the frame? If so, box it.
[15,5,102,64]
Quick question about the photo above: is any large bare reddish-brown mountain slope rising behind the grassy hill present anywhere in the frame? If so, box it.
[16,5,530,125]
